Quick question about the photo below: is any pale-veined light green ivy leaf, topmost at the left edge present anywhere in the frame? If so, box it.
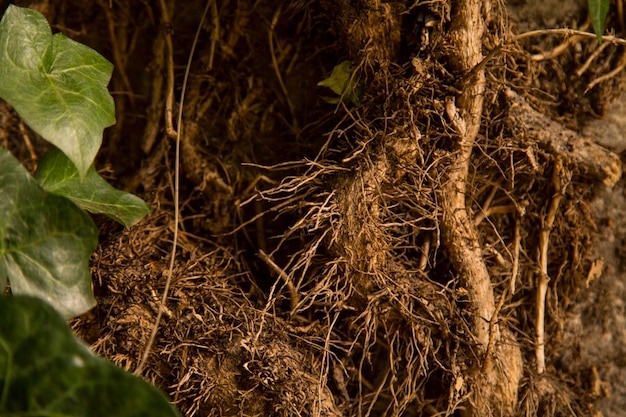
[0,6,115,178]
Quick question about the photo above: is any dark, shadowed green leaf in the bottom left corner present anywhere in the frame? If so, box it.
[0,296,179,417]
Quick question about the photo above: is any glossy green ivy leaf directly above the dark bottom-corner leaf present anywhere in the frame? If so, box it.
[0,148,98,321]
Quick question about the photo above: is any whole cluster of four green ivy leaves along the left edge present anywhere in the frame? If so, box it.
[0,6,179,417]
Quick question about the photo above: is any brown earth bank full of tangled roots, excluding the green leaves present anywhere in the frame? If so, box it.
[0,0,626,417]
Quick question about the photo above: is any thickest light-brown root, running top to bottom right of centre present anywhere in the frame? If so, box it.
[441,0,522,416]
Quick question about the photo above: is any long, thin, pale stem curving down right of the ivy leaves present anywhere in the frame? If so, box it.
[135,0,214,376]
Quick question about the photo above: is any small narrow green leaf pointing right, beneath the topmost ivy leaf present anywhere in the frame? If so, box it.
[35,149,150,227]
